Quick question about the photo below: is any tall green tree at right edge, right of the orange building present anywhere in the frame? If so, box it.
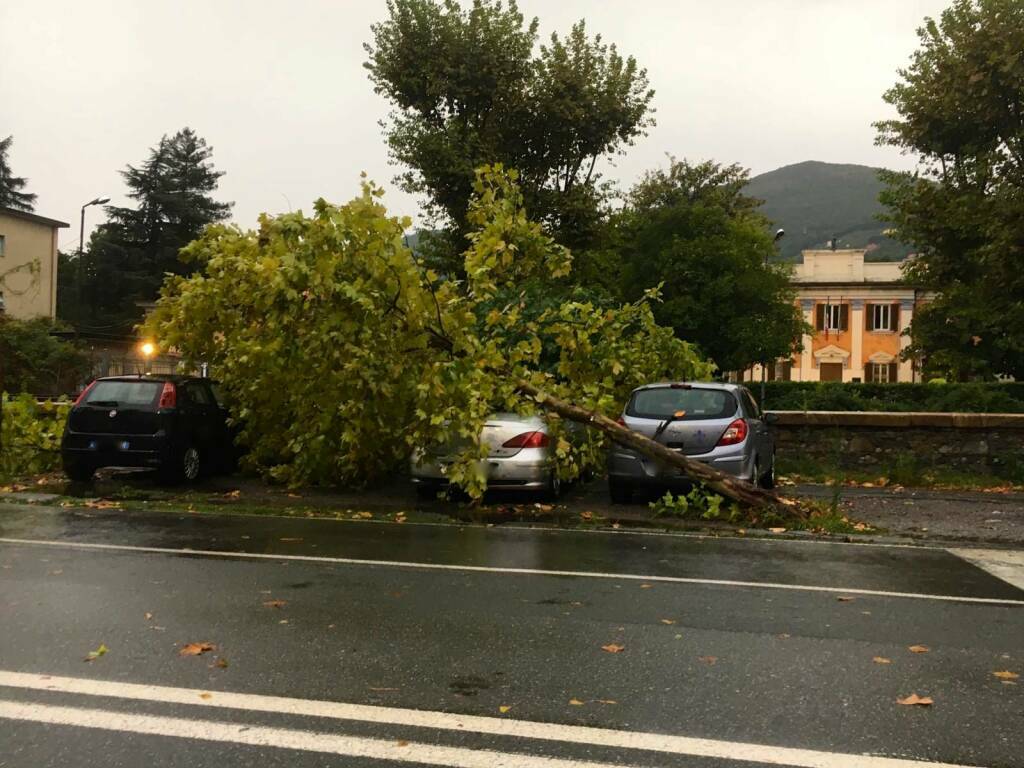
[876,0,1024,379]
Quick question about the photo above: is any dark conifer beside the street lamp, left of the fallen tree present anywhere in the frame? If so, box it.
[69,128,231,331]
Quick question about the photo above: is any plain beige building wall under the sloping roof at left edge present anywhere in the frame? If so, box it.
[0,212,57,319]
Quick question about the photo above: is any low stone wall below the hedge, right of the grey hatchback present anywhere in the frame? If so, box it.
[772,411,1024,474]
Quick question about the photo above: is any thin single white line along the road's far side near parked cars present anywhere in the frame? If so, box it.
[0,537,1024,605]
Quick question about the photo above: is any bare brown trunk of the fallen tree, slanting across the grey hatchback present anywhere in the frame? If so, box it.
[518,381,807,519]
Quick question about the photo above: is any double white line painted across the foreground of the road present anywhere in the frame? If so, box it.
[0,671,966,768]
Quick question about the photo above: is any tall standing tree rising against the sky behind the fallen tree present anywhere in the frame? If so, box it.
[366,0,653,259]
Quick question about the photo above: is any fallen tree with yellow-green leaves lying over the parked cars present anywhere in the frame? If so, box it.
[150,167,800,515]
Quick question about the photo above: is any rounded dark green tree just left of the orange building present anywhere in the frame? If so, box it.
[611,159,804,372]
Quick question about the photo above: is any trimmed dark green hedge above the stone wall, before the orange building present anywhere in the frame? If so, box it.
[761,381,1024,414]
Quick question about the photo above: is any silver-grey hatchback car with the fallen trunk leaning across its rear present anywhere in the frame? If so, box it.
[608,382,775,504]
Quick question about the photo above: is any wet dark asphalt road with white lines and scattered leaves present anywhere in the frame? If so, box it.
[0,505,1024,768]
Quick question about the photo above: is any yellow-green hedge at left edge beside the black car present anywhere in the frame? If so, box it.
[0,394,71,480]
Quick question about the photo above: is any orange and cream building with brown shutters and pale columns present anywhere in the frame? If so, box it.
[744,249,927,382]
